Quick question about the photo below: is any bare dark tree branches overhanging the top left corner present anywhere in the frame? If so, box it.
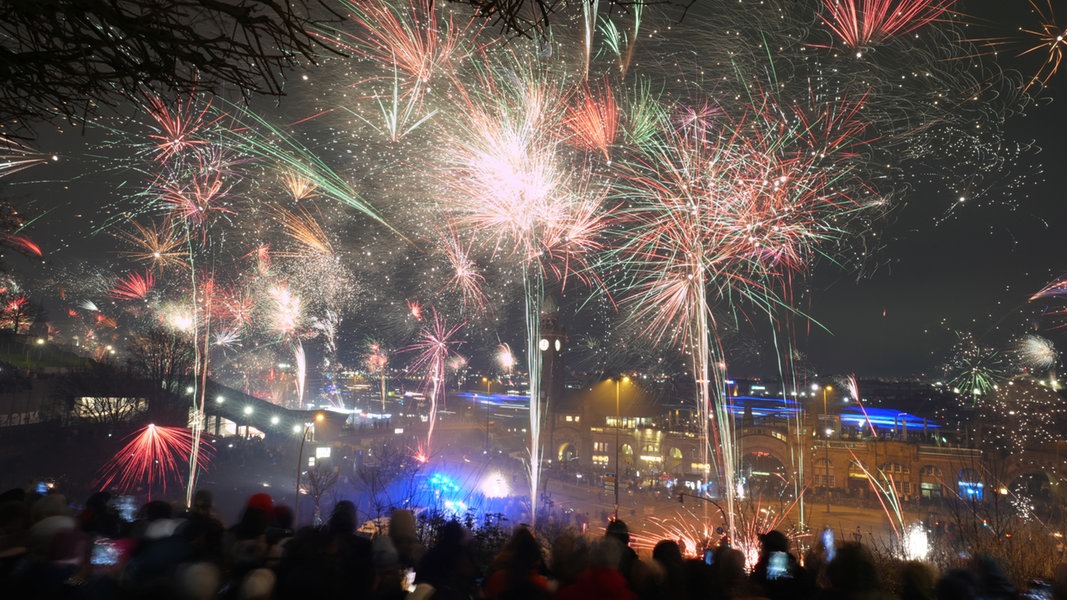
[0,0,337,127]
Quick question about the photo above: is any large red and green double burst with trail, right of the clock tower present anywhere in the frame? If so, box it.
[616,85,863,531]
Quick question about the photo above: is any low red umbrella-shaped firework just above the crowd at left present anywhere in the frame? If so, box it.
[97,424,213,500]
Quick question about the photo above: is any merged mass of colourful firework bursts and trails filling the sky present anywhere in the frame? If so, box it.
[0,0,1064,529]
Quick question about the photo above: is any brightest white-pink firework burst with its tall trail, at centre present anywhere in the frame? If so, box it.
[436,54,610,520]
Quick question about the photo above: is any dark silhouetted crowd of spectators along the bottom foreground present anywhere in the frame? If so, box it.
[0,489,1054,600]
